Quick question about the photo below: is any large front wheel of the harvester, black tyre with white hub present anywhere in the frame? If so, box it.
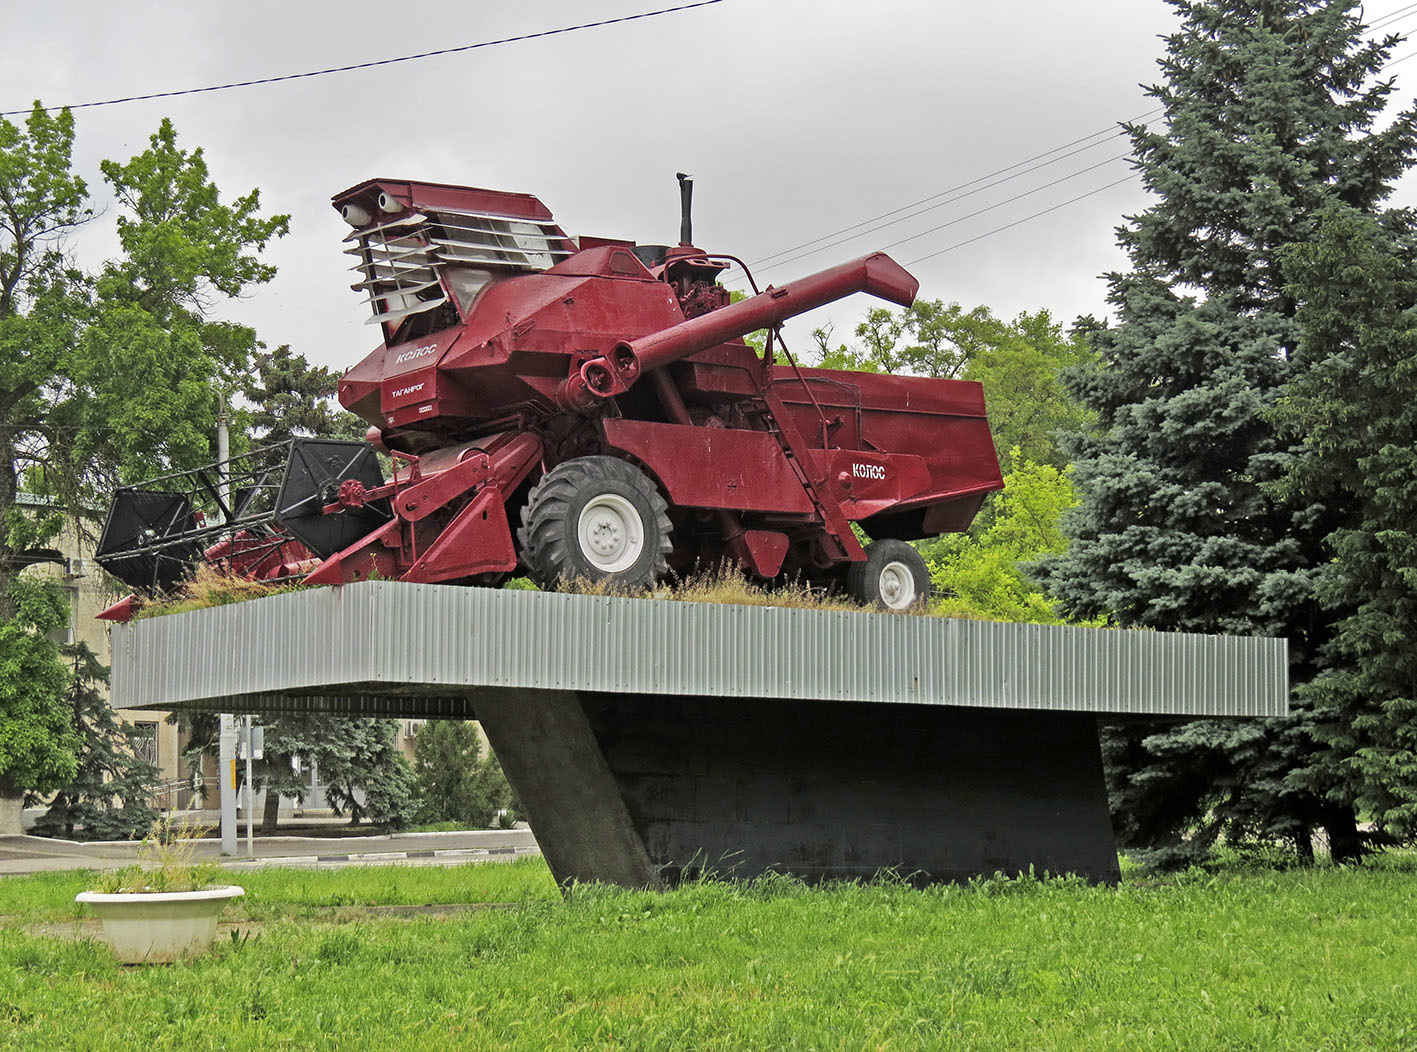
[519,457,670,591]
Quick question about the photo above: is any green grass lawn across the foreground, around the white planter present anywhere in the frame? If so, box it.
[0,858,1417,1052]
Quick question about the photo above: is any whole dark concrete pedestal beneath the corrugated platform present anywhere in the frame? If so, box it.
[476,692,1118,886]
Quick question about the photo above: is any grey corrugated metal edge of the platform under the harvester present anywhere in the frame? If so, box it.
[112,581,1288,716]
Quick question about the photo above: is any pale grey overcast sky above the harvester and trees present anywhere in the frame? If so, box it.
[8,0,1417,369]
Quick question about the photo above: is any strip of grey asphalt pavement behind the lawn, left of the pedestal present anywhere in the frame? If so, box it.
[0,827,540,876]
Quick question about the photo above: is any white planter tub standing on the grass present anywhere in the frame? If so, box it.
[74,885,245,964]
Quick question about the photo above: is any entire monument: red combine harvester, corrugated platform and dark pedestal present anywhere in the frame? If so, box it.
[98,177,1287,885]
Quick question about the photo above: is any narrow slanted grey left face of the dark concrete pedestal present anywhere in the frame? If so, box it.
[475,689,659,888]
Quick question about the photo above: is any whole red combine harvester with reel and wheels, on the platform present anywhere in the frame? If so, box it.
[98,177,1003,618]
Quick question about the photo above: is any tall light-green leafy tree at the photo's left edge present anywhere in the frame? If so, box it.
[0,103,286,822]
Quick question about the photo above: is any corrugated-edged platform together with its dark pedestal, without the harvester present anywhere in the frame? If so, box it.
[112,581,1288,886]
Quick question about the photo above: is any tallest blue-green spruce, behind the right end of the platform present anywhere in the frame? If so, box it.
[1041,0,1417,861]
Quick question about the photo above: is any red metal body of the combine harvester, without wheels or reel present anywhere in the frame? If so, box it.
[307,180,1002,583]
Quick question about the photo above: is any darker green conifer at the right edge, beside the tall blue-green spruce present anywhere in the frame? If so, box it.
[1275,208,1417,838]
